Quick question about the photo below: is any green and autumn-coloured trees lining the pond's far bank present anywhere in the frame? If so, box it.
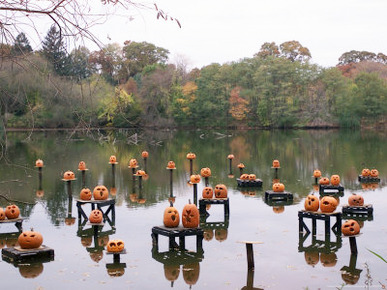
[0,26,387,128]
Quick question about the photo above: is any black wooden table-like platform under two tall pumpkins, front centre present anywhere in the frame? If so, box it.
[151,226,204,251]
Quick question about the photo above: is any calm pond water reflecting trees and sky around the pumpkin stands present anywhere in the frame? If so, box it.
[0,130,387,289]
